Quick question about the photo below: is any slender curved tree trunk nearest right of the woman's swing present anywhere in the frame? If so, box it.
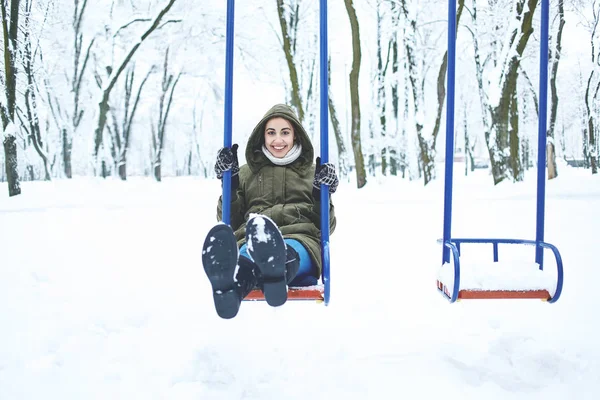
[344,0,367,189]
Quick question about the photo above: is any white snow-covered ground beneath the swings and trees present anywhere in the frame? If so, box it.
[0,166,600,400]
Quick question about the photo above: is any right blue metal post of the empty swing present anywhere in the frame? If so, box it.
[535,0,549,269]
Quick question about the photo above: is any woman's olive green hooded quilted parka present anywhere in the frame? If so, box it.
[217,104,336,274]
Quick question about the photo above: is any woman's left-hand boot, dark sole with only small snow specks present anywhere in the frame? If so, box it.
[202,224,242,319]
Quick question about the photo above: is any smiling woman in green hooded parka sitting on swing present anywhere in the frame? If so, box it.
[202,104,338,318]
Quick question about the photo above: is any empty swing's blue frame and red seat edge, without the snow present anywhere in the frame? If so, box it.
[438,0,563,303]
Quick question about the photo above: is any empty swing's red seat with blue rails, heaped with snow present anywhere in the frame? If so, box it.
[437,239,563,303]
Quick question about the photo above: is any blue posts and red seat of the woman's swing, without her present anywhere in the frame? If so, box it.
[222,0,331,305]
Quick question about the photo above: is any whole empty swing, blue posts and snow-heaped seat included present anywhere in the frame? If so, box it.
[437,0,563,303]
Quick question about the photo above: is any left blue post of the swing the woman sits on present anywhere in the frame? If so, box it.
[222,0,235,224]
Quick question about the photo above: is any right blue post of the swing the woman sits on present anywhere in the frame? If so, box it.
[319,0,331,305]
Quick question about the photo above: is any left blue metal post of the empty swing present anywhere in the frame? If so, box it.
[442,0,456,263]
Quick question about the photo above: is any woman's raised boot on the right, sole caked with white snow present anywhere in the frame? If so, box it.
[246,215,287,307]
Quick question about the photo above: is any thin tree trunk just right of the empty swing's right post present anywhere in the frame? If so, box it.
[546,0,565,180]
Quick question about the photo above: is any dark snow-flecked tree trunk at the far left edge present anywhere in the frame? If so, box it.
[0,0,21,196]
